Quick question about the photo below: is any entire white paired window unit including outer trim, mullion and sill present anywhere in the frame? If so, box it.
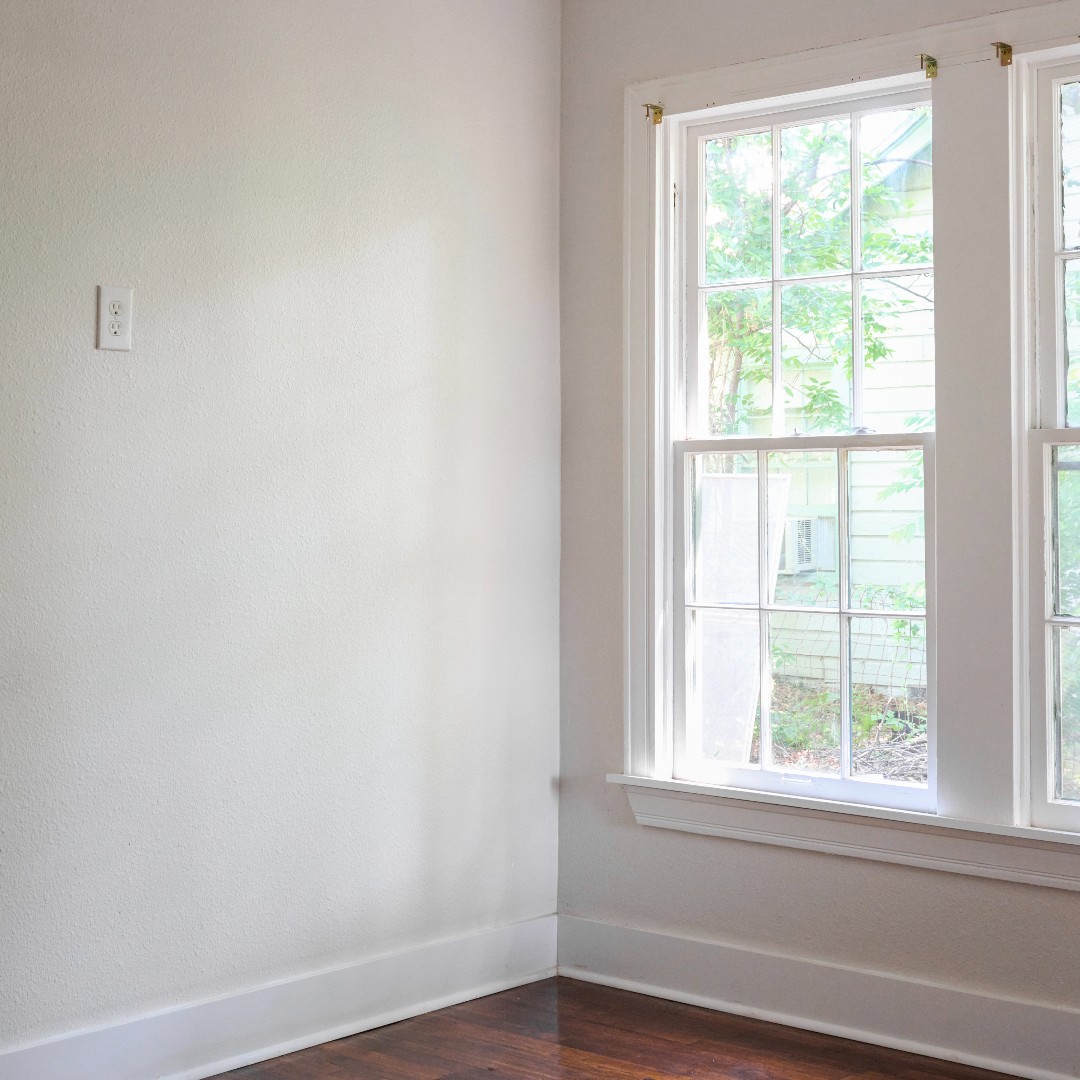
[609,4,1080,889]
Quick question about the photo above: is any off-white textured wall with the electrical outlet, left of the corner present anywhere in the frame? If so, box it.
[0,0,559,1050]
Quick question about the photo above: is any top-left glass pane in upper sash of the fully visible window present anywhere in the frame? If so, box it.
[705,132,772,285]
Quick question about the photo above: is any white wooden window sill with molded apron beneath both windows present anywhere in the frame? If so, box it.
[607,773,1080,891]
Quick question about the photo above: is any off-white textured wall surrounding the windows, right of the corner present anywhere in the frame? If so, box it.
[559,0,1080,1007]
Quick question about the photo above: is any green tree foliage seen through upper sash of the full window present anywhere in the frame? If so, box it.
[705,108,932,434]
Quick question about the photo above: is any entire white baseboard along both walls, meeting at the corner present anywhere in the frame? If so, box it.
[12,916,1080,1080]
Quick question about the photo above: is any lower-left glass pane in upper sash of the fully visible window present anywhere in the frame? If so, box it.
[705,286,772,435]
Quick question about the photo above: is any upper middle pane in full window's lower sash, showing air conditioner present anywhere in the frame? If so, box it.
[768,450,840,608]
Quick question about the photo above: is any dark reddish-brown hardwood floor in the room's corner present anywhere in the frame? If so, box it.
[226,978,1019,1080]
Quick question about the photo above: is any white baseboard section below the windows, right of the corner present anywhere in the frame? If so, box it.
[558,915,1080,1080]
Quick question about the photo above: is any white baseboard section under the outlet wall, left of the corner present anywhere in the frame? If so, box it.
[0,915,556,1080]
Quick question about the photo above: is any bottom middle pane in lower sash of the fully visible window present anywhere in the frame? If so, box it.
[766,611,840,775]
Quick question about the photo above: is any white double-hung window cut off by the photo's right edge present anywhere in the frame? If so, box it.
[1030,50,1080,828]
